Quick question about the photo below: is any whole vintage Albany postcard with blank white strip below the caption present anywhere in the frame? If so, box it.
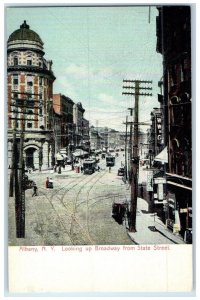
[5,5,194,295]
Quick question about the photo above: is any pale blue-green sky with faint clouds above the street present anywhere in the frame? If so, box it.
[6,5,163,131]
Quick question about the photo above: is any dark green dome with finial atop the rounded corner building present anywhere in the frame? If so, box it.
[8,21,43,45]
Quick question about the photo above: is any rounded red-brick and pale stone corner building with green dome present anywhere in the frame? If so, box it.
[7,21,55,169]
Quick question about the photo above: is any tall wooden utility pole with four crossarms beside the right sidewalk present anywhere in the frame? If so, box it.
[122,80,152,232]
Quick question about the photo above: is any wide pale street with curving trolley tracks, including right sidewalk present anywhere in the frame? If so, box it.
[9,152,183,246]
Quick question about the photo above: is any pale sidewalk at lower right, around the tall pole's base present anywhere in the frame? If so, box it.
[128,198,185,245]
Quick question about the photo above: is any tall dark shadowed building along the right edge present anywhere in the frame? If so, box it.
[157,6,192,239]
